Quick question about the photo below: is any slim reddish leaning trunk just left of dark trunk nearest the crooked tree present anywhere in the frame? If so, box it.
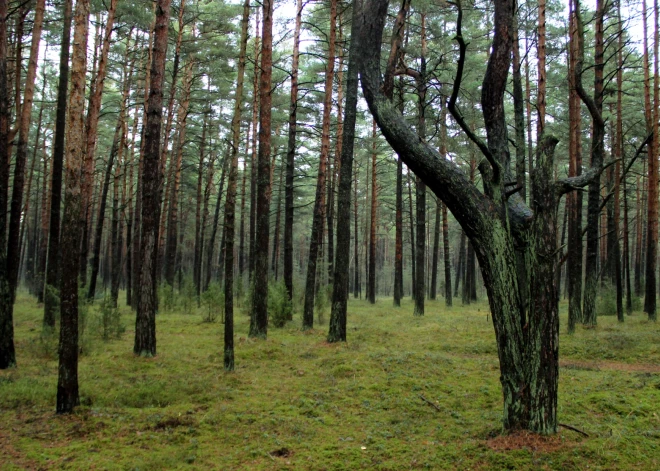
[303,0,337,329]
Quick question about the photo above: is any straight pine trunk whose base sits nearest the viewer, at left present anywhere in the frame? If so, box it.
[56,0,89,414]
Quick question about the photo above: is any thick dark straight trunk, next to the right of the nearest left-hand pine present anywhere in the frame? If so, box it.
[133,0,171,357]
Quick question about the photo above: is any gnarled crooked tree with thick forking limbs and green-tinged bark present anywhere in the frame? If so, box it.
[358,0,600,433]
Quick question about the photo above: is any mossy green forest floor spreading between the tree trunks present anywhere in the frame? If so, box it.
[0,295,660,471]
